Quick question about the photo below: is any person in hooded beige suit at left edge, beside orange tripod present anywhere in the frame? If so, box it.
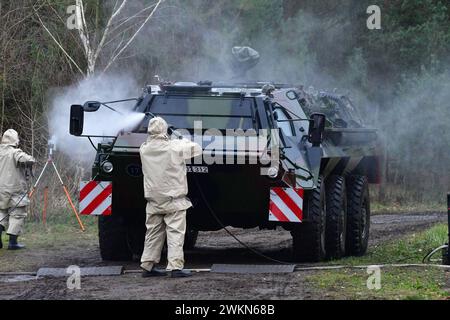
[0,129,35,250]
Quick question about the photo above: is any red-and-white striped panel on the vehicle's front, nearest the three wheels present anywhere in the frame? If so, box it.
[269,188,304,222]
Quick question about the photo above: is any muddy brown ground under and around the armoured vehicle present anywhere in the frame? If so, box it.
[0,213,446,300]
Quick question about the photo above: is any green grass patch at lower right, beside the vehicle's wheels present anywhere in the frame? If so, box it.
[307,224,449,300]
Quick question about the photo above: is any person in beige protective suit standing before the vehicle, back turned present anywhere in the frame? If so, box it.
[140,117,202,277]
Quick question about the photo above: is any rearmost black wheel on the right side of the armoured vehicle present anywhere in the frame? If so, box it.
[346,176,370,256]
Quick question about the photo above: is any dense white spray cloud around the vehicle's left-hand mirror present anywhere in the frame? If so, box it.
[49,75,144,163]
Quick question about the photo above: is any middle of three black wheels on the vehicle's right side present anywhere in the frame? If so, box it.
[325,176,347,259]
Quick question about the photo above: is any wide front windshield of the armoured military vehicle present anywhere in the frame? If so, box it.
[139,96,254,131]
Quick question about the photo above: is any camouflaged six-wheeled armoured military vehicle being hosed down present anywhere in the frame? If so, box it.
[70,82,380,261]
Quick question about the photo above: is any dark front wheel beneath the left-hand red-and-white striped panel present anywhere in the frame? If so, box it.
[98,215,132,261]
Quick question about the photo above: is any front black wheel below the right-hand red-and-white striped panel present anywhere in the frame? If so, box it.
[291,178,326,262]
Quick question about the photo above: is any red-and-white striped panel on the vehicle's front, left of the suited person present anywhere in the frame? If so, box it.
[79,181,112,216]
